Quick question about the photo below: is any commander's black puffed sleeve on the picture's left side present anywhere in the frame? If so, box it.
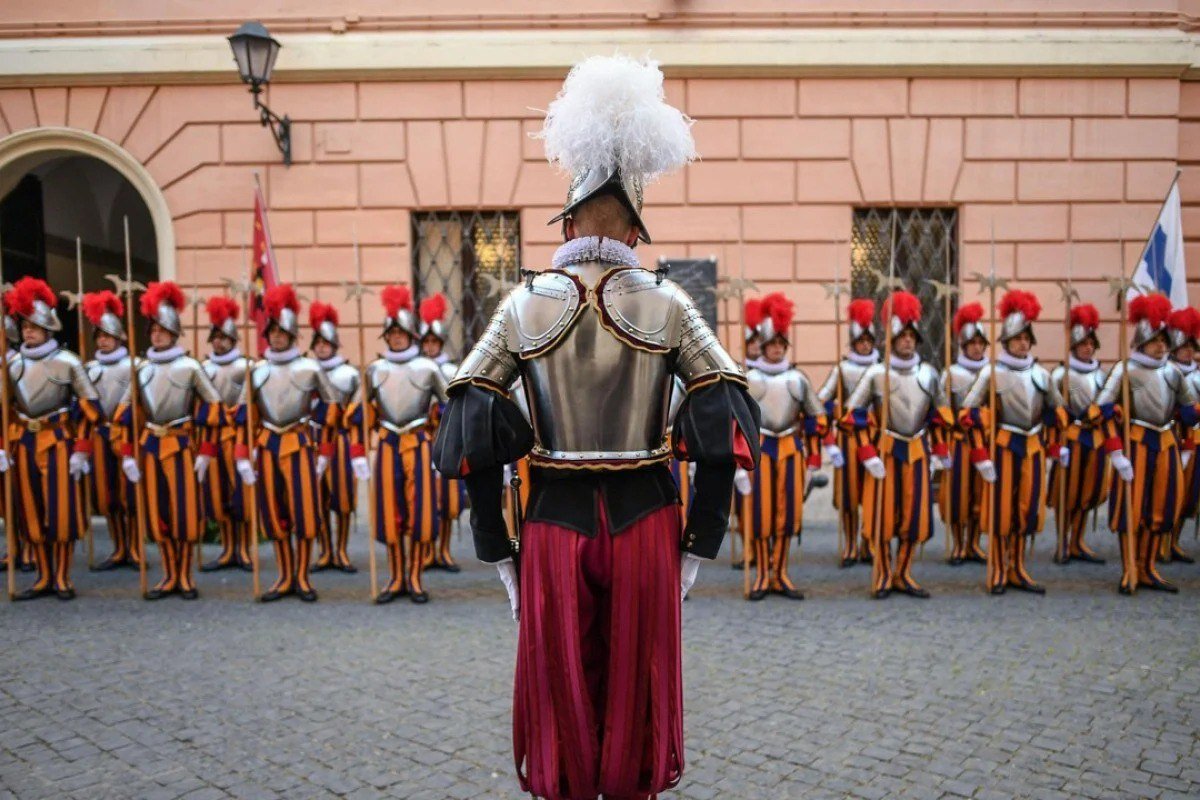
[433,384,533,563]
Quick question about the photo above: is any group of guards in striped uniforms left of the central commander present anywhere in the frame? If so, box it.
[0,277,466,603]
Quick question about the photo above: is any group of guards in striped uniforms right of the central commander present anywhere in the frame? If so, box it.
[734,289,1200,600]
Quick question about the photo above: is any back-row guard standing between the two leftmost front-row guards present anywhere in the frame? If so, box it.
[83,289,138,572]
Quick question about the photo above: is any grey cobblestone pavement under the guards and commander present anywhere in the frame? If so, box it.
[0,503,1200,800]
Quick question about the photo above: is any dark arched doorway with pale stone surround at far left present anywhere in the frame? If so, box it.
[0,128,174,349]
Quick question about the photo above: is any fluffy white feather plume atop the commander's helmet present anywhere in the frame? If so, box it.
[536,55,696,181]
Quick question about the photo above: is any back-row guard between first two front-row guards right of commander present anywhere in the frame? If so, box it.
[817,299,880,569]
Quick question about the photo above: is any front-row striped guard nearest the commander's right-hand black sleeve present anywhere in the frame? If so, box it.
[733,293,841,600]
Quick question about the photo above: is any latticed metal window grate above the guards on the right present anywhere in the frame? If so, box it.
[850,209,959,367]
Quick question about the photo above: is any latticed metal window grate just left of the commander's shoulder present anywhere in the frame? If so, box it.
[413,211,521,359]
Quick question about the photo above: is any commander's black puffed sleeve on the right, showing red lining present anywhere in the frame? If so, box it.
[674,380,760,559]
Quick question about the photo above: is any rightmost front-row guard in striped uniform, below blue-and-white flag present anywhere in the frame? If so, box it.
[1090,295,1200,595]
